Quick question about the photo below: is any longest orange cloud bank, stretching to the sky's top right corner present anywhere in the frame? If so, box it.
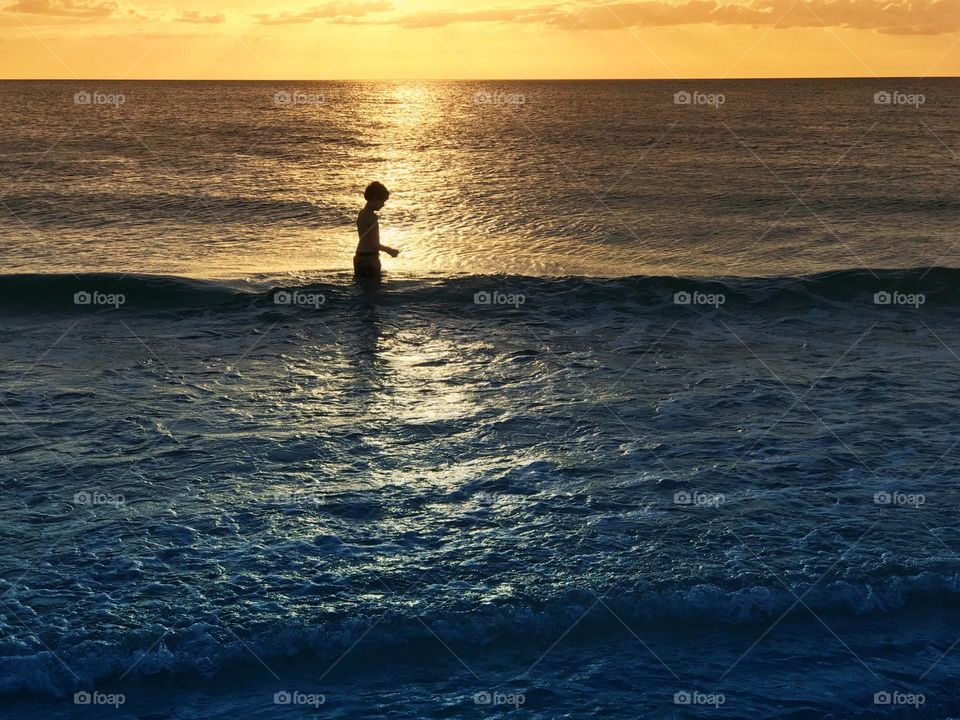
[382,0,960,35]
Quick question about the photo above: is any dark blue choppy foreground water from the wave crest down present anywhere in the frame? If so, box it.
[0,270,960,718]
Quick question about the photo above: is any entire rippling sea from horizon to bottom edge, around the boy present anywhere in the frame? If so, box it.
[0,79,960,720]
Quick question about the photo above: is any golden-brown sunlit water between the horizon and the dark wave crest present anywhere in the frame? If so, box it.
[0,79,960,277]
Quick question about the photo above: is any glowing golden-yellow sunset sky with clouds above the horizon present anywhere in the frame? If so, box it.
[0,0,960,80]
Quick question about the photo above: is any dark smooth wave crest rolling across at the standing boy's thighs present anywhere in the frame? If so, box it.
[0,267,960,314]
